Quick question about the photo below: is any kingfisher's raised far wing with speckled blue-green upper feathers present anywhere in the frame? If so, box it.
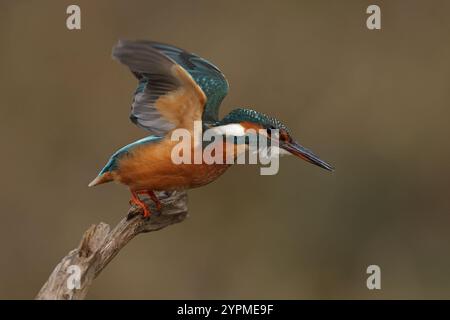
[147,41,228,123]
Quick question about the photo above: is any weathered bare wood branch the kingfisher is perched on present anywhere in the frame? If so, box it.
[36,192,187,300]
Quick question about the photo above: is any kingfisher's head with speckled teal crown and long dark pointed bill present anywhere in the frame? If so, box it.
[218,108,334,171]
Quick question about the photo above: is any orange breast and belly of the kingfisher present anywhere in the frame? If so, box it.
[114,138,230,191]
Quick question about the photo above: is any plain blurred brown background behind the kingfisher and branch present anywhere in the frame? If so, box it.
[0,0,450,299]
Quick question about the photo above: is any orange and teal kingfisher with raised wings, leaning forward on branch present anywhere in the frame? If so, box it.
[89,40,334,217]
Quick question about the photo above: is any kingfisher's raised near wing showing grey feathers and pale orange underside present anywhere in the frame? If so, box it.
[113,40,206,136]
